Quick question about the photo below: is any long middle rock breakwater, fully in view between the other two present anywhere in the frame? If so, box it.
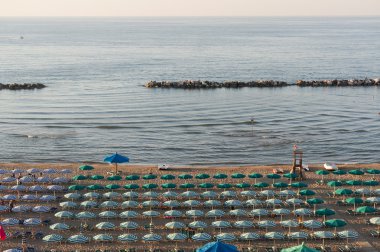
[145,80,289,89]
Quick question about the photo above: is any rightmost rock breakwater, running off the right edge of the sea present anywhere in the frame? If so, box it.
[296,78,380,87]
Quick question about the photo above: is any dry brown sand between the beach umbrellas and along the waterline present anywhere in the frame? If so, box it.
[0,163,380,251]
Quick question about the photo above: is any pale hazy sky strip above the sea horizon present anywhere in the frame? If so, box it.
[0,0,380,16]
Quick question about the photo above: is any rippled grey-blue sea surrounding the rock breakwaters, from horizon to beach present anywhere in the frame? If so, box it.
[0,17,380,164]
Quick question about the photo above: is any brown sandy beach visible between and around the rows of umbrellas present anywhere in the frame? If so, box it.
[0,163,380,251]
